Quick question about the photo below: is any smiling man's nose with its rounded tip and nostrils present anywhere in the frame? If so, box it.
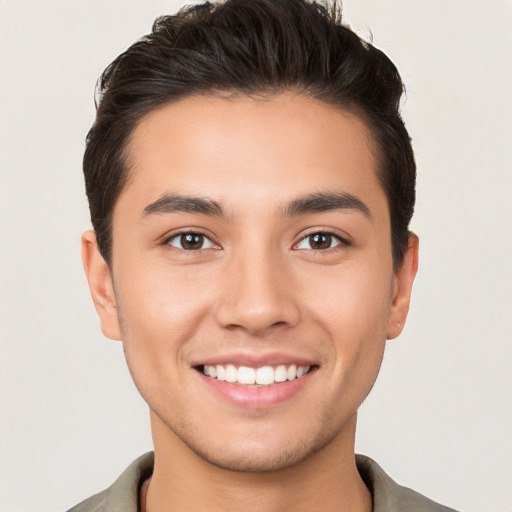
[216,247,300,336]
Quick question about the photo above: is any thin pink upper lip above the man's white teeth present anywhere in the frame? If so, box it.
[191,352,318,368]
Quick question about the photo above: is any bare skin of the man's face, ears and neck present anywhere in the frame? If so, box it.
[82,93,418,511]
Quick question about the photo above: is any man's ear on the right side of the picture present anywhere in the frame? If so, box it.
[387,233,419,340]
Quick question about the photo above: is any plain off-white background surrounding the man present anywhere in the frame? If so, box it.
[0,0,512,512]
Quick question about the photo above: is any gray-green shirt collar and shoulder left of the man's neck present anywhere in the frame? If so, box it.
[64,452,154,512]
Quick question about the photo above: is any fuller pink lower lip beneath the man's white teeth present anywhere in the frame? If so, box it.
[198,368,316,409]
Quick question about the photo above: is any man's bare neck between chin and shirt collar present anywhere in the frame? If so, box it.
[145,414,372,512]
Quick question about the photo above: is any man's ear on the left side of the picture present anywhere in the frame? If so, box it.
[82,231,121,340]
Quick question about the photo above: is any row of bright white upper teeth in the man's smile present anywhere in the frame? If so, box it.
[203,364,311,386]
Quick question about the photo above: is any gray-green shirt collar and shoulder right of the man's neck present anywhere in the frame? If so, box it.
[356,455,456,512]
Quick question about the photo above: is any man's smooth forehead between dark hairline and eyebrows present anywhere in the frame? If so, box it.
[120,93,383,216]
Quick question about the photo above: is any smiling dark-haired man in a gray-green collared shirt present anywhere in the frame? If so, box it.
[72,0,458,512]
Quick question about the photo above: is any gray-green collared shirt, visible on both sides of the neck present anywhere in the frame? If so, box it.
[68,452,455,512]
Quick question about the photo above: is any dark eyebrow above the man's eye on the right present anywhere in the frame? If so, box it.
[284,192,372,219]
